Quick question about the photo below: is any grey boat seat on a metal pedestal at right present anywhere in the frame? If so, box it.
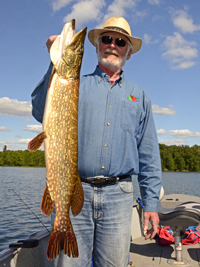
[158,202,200,266]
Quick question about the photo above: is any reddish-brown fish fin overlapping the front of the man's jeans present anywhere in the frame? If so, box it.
[71,177,84,216]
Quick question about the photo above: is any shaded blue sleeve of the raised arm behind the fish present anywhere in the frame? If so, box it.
[31,63,53,123]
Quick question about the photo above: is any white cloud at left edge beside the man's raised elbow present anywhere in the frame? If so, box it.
[0,97,32,117]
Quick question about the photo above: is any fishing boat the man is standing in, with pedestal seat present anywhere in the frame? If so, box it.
[0,189,200,267]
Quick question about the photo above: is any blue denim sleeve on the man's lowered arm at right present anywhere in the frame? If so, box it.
[137,96,162,212]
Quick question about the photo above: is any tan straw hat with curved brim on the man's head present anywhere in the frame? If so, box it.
[88,16,142,54]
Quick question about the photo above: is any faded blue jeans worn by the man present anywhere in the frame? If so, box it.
[54,178,133,267]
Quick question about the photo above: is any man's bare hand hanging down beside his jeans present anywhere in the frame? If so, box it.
[143,214,159,240]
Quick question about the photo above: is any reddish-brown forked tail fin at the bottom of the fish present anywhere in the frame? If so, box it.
[47,226,79,260]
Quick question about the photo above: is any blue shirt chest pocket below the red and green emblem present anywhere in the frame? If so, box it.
[120,101,140,132]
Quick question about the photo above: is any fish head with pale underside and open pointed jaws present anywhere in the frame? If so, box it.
[50,19,87,78]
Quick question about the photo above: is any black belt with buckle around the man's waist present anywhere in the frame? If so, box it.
[81,175,131,186]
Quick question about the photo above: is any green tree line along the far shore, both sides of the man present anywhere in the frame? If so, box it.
[0,144,200,172]
